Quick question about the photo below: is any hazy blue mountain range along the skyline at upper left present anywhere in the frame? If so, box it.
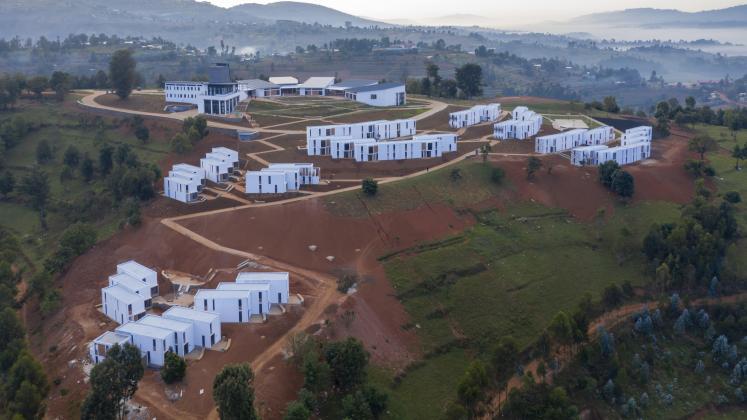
[0,0,389,45]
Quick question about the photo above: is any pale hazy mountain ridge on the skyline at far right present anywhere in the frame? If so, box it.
[568,4,747,27]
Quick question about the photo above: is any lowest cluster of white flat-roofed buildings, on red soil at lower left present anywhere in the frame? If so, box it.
[89,261,289,367]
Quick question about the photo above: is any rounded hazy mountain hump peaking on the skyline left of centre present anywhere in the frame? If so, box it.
[228,1,388,26]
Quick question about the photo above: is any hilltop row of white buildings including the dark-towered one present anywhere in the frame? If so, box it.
[164,63,407,115]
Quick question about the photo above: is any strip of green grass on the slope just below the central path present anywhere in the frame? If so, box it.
[324,161,507,217]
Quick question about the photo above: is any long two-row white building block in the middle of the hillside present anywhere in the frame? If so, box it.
[306,119,457,162]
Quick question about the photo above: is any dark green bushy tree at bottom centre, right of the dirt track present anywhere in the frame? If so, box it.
[324,337,369,391]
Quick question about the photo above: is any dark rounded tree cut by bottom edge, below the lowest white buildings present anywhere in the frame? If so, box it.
[213,363,259,420]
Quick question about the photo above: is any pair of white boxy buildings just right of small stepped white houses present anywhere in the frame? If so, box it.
[245,163,320,194]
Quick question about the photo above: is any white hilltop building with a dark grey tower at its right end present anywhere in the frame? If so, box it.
[164,63,241,115]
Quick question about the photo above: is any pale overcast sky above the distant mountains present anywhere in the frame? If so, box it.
[202,0,744,23]
